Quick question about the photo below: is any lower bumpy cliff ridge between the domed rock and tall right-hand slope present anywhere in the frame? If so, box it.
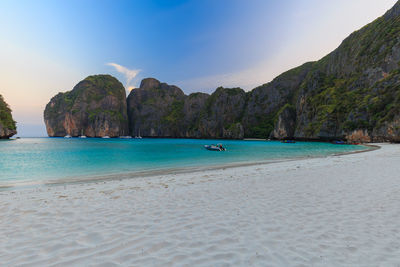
[127,78,246,139]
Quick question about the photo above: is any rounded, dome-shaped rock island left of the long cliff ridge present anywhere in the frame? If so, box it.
[44,75,129,137]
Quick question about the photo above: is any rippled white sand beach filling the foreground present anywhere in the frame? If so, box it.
[0,144,400,266]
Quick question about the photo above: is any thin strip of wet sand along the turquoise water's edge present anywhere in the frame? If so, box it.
[0,143,380,189]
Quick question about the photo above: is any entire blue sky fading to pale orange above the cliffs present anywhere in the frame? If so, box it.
[0,0,396,137]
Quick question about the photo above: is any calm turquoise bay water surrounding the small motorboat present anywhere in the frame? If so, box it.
[0,138,365,185]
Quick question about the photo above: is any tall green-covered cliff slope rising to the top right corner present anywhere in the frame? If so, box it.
[243,2,400,142]
